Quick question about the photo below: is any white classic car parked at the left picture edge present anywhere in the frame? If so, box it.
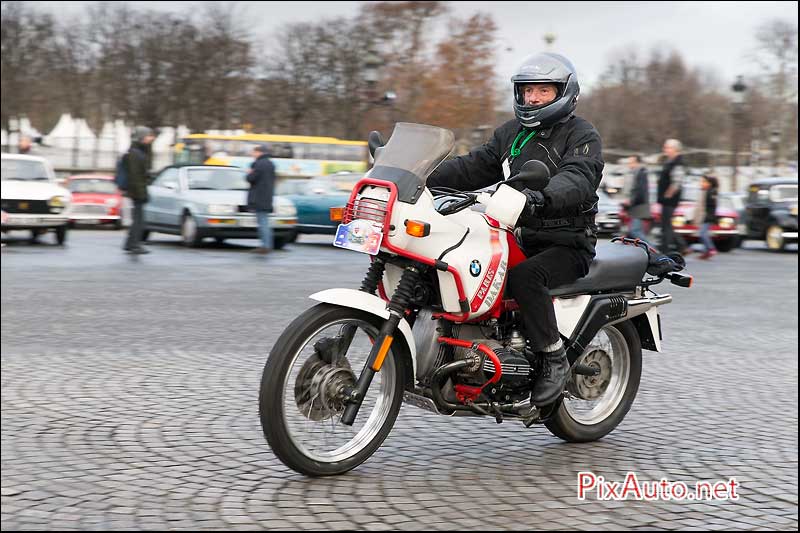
[0,153,72,244]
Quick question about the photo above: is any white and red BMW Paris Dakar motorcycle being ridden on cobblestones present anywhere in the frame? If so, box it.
[259,123,692,476]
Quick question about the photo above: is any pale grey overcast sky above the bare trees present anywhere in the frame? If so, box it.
[30,1,798,92]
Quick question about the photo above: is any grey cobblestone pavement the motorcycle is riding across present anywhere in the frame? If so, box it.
[1,231,798,530]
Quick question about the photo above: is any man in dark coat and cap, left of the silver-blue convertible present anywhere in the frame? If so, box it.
[123,126,156,254]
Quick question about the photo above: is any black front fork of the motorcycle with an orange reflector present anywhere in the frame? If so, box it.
[340,260,419,426]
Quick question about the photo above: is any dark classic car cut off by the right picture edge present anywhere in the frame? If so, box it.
[746,178,797,251]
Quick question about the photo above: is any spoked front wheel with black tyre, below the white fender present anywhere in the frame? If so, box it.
[259,304,406,476]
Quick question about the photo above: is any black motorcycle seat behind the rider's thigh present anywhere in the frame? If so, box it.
[550,243,648,296]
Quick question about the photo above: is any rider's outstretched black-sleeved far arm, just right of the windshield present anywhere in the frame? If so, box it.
[426,130,503,191]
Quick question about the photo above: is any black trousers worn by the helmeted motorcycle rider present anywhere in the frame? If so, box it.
[508,246,593,352]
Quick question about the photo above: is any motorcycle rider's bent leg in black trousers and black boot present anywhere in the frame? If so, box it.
[509,246,592,405]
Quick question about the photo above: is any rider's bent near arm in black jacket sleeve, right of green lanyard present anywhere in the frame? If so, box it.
[543,121,605,210]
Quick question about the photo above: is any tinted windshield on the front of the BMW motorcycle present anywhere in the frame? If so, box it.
[367,122,455,203]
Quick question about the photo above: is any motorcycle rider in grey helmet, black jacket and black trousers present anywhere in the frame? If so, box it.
[427,52,604,406]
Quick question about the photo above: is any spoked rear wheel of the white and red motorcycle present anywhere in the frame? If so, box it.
[545,321,642,442]
